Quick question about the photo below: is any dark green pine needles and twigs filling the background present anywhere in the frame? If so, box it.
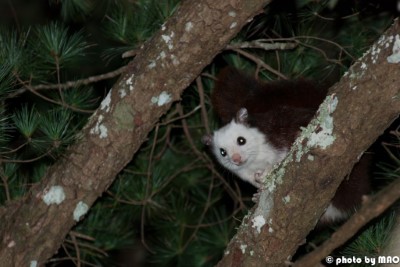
[0,0,400,266]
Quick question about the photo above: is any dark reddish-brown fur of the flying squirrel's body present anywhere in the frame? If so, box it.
[212,67,371,224]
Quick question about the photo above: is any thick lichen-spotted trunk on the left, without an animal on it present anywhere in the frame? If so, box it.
[0,0,269,267]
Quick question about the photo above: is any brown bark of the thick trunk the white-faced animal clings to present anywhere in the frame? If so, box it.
[218,20,400,267]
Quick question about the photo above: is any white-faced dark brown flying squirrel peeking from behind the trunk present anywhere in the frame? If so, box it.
[202,67,370,224]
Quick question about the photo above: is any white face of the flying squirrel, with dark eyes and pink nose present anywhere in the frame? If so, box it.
[212,120,265,171]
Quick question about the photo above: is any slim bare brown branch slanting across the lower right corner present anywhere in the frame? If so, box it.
[293,179,400,267]
